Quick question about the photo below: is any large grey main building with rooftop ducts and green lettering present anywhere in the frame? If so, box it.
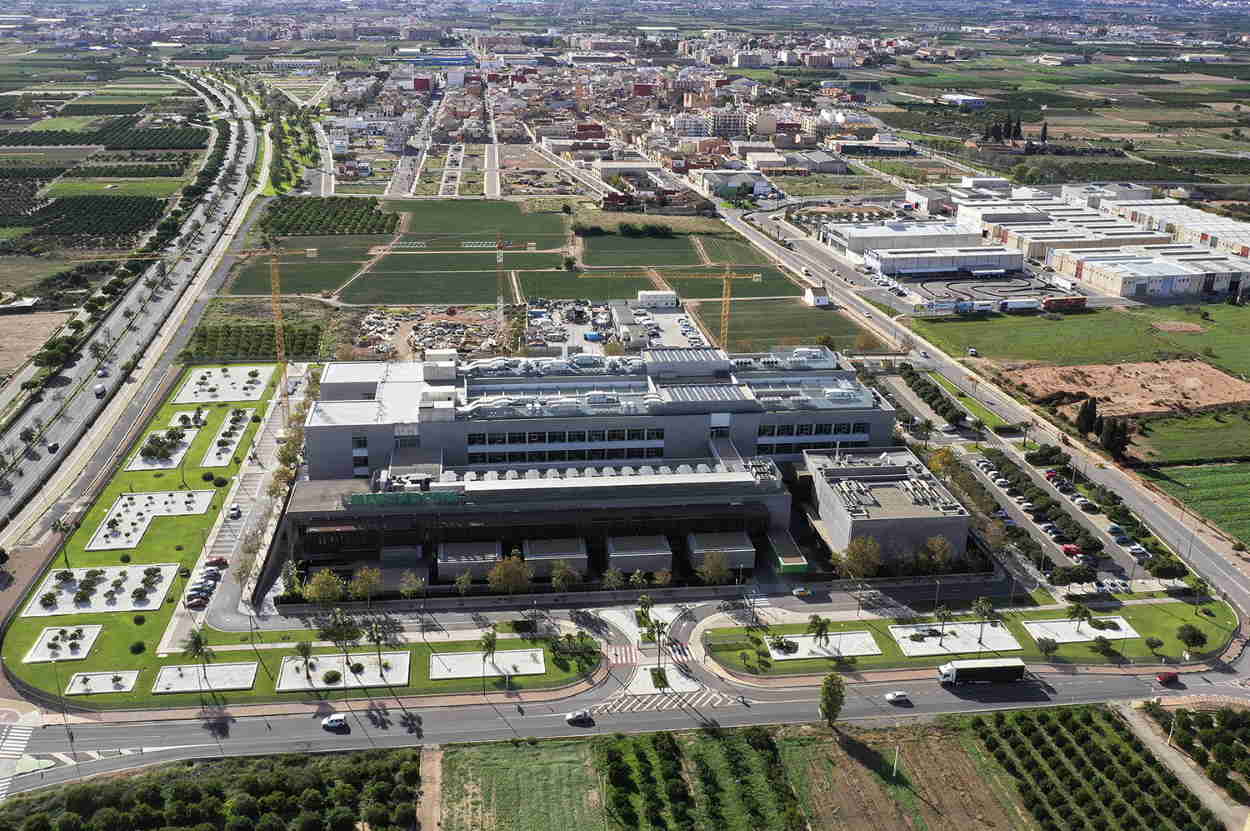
[285,347,910,581]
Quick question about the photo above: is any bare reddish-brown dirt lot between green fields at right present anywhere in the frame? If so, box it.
[1010,361,1250,416]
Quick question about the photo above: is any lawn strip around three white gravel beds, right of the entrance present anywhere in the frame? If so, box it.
[708,601,1236,675]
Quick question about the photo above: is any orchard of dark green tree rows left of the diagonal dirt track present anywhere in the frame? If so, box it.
[971,707,1224,831]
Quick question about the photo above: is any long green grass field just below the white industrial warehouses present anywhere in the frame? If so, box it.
[909,304,1250,375]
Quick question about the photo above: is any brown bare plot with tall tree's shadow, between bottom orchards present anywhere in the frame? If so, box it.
[783,727,1033,831]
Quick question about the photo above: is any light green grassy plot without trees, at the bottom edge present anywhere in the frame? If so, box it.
[440,740,604,831]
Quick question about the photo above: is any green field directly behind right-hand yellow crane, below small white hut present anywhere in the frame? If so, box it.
[698,298,864,352]
